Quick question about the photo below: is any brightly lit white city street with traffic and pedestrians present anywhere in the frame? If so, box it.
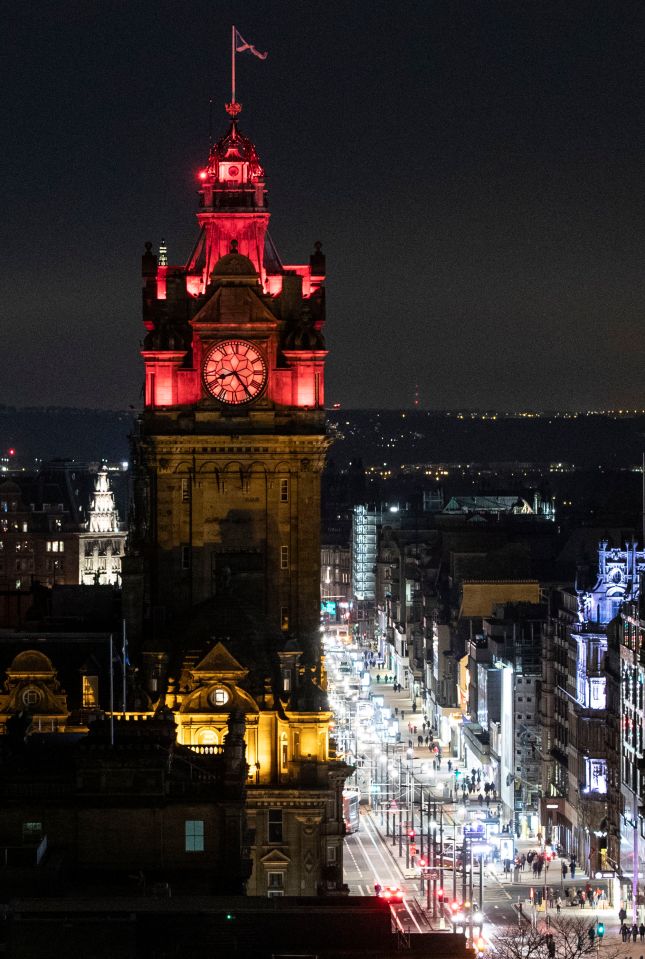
[326,629,628,957]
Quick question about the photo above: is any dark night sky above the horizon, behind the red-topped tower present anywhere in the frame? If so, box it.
[0,0,645,409]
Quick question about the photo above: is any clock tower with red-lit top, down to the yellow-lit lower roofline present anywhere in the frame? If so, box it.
[126,105,328,688]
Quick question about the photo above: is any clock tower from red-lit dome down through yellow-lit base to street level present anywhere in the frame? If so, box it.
[124,101,348,896]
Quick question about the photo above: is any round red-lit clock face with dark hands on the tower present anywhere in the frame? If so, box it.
[203,340,267,405]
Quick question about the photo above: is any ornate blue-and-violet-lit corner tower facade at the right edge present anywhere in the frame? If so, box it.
[568,541,645,877]
